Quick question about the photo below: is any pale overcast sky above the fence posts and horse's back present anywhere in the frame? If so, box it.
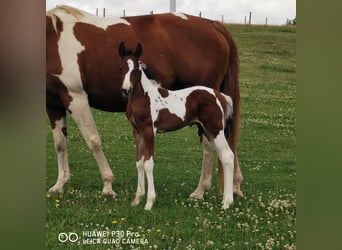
[46,0,296,25]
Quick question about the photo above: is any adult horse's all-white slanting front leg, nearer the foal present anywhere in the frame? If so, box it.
[68,92,116,196]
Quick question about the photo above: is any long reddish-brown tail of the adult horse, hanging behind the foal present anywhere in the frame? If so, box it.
[214,22,242,196]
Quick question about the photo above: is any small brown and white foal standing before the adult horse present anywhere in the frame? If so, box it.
[119,42,234,210]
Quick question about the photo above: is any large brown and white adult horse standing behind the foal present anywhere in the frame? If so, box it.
[46,6,242,199]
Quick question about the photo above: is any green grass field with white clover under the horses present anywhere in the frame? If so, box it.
[46,25,296,249]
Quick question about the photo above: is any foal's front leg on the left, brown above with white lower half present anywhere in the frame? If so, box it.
[132,129,145,206]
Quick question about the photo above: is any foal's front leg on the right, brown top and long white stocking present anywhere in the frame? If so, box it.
[142,127,156,210]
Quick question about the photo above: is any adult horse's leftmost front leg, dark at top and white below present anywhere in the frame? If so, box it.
[47,107,70,193]
